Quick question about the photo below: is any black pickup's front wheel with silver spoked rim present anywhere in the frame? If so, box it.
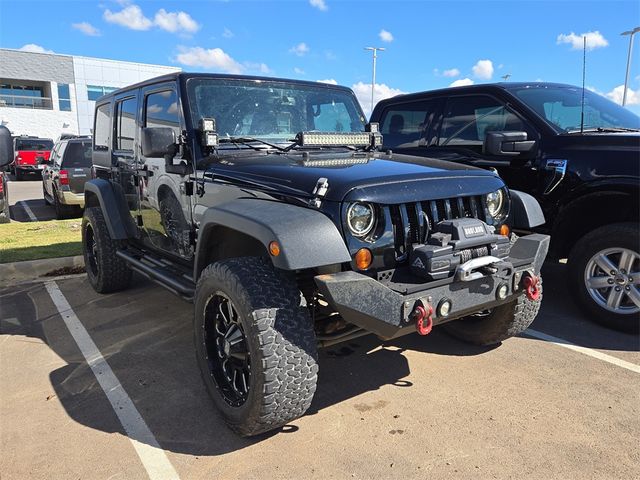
[569,222,640,333]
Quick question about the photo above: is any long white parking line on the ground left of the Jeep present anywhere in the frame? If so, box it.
[45,282,179,480]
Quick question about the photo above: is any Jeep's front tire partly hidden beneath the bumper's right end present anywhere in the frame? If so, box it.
[443,276,542,345]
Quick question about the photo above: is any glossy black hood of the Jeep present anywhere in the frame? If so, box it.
[207,152,504,203]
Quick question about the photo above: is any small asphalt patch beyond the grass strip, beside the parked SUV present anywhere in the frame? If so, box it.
[7,175,66,222]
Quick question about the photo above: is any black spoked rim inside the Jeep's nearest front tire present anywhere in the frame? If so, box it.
[203,292,251,407]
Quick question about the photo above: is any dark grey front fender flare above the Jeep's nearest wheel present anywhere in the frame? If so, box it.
[194,199,351,276]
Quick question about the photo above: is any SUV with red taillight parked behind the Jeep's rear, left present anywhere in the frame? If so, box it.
[42,137,92,219]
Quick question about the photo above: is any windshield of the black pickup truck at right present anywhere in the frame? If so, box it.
[511,86,640,132]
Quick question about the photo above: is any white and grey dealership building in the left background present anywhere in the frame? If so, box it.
[0,48,180,140]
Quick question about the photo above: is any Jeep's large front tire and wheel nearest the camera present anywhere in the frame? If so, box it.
[194,257,318,436]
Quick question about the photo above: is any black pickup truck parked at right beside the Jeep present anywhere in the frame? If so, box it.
[371,83,640,332]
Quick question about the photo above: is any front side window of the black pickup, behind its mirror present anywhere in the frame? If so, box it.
[438,95,534,153]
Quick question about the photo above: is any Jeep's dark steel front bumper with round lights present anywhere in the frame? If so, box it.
[315,234,549,339]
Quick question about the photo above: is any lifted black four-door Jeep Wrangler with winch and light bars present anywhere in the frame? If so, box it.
[82,73,549,435]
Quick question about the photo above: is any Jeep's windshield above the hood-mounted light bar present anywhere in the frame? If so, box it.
[187,78,365,143]
